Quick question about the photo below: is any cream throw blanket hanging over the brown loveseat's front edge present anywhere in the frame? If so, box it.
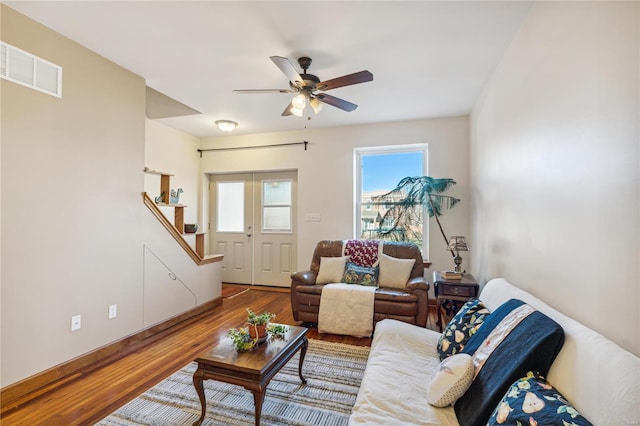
[318,283,376,337]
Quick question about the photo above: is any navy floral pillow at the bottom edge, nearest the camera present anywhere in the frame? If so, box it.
[487,371,591,426]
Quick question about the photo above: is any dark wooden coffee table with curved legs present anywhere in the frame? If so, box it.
[193,325,309,426]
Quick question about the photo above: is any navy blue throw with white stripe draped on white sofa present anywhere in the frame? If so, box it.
[454,299,564,426]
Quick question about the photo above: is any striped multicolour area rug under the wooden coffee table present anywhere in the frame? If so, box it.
[97,340,369,426]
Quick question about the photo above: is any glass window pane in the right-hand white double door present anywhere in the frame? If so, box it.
[262,180,292,233]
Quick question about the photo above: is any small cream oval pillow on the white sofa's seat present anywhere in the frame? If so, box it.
[427,354,474,407]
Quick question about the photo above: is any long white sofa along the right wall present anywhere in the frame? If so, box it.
[349,278,640,426]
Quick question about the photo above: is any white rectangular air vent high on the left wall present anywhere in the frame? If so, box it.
[0,41,62,98]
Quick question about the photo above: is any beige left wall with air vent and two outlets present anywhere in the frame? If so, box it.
[0,5,145,386]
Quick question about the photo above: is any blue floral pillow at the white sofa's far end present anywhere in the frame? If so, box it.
[437,298,489,361]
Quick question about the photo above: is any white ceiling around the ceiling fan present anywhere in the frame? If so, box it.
[4,1,531,137]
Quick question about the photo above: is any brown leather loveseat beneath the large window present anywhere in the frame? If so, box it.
[291,240,429,327]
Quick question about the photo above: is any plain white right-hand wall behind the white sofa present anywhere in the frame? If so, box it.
[471,2,640,354]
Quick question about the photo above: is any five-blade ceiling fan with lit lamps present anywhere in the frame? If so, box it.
[233,56,373,117]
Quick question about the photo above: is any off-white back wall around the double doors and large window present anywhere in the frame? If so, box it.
[202,116,474,276]
